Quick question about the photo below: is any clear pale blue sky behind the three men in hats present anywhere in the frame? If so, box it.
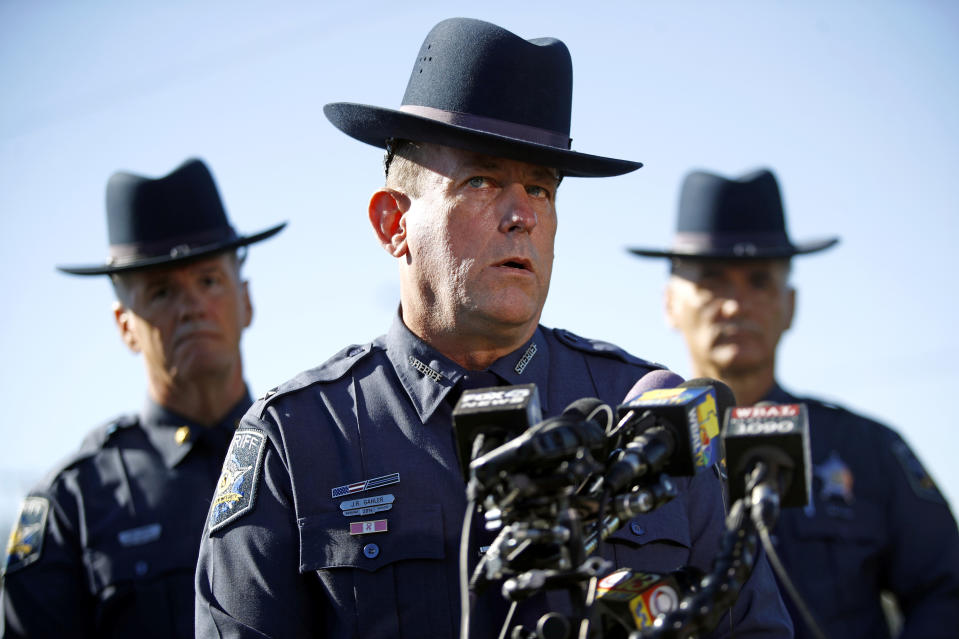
[0,0,959,535]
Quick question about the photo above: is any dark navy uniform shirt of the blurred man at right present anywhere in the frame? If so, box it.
[765,386,959,639]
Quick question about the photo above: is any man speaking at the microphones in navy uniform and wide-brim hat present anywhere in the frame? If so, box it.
[197,18,789,639]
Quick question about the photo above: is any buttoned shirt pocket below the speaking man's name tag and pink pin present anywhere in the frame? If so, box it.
[299,504,457,637]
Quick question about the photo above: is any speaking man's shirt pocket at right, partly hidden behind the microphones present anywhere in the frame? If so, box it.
[603,498,692,573]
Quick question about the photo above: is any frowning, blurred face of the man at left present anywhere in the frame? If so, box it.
[115,254,253,383]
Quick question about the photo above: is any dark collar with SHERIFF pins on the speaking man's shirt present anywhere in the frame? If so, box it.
[386,313,549,423]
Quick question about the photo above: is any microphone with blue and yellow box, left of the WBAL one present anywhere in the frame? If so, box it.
[605,378,731,492]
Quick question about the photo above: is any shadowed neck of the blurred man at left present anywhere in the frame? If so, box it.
[148,365,246,427]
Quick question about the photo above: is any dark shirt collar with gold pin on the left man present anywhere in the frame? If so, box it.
[140,390,253,468]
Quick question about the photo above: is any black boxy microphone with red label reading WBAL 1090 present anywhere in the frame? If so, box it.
[723,402,812,507]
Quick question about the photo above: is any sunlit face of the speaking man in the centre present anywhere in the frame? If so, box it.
[403,145,559,340]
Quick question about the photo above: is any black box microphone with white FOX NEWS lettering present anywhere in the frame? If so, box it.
[453,384,543,481]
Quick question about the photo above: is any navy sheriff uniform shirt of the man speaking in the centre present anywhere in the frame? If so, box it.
[196,317,791,639]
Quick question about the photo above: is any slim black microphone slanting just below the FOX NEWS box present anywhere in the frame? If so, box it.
[470,399,611,489]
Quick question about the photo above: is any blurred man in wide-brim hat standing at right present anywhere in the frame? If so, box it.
[630,169,959,639]
